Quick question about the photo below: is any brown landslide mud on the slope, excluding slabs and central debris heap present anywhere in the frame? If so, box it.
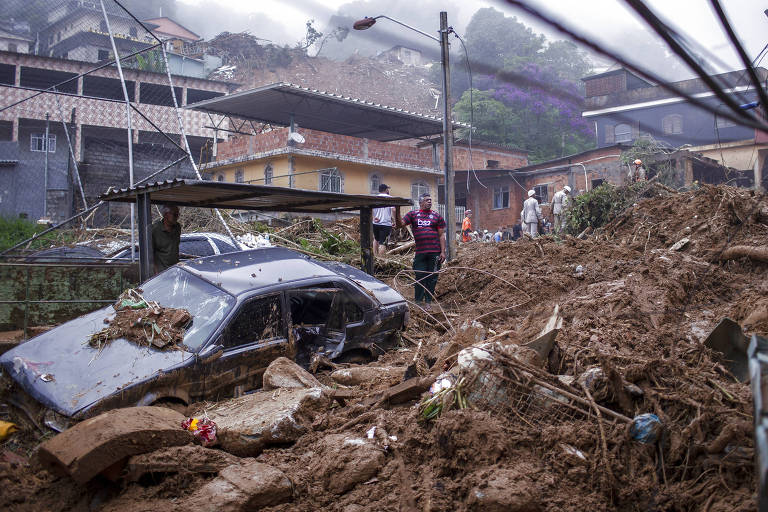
[0,186,768,512]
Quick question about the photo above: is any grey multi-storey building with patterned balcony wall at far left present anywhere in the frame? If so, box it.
[0,52,237,221]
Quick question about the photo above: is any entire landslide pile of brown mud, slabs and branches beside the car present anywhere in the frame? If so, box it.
[0,186,768,512]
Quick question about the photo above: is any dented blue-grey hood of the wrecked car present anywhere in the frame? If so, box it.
[0,306,194,416]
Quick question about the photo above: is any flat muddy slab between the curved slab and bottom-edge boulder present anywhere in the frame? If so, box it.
[125,444,242,482]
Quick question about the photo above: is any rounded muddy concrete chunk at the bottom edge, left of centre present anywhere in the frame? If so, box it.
[182,459,293,512]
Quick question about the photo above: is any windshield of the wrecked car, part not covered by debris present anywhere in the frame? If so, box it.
[141,267,235,352]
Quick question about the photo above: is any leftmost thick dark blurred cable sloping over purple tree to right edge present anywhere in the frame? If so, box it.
[497,0,768,131]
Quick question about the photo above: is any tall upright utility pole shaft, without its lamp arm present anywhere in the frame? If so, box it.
[440,11,456,261]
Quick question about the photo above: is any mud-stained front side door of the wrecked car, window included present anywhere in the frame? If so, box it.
[201,292,294,400]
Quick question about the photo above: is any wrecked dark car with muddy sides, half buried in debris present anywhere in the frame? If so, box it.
[0,247,408,430]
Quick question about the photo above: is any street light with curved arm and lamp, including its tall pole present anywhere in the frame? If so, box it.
[352,11,456,261]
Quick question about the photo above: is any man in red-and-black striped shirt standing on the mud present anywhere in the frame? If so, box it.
[395,193,446,305]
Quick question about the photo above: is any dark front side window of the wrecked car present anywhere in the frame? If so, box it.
[224,294,283,348]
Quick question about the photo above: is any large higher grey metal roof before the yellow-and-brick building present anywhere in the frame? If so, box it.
[186,82,469,142]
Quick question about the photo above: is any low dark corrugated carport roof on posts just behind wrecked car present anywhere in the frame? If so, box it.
[100,179,411,213]
